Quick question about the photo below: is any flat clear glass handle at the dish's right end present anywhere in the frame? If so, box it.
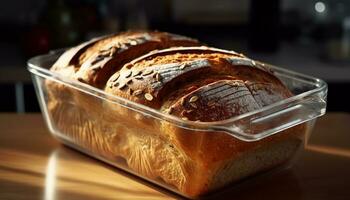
[216,97,326,142]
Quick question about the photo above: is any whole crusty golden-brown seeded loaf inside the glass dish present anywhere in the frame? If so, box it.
[47,32,305,197]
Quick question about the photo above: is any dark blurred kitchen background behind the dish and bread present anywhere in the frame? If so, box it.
[0,0,350,112]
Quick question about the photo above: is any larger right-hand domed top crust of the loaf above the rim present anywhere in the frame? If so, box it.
[105,47,291,121]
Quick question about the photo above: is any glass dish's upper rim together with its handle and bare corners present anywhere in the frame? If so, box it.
[28,52,327,141]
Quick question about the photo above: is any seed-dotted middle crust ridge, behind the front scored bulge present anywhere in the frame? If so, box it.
[105,47,292,109]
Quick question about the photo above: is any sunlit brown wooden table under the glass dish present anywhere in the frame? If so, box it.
[0,113,350,200]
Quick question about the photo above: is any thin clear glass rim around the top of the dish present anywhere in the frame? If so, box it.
[27,49,328,142]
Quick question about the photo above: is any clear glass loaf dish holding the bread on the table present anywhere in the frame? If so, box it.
[28,51,327,198]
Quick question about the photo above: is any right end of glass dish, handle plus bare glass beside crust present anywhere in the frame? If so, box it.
[215,64,327,141]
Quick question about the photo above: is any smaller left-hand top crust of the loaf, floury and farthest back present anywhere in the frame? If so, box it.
[53,31,199,88]
